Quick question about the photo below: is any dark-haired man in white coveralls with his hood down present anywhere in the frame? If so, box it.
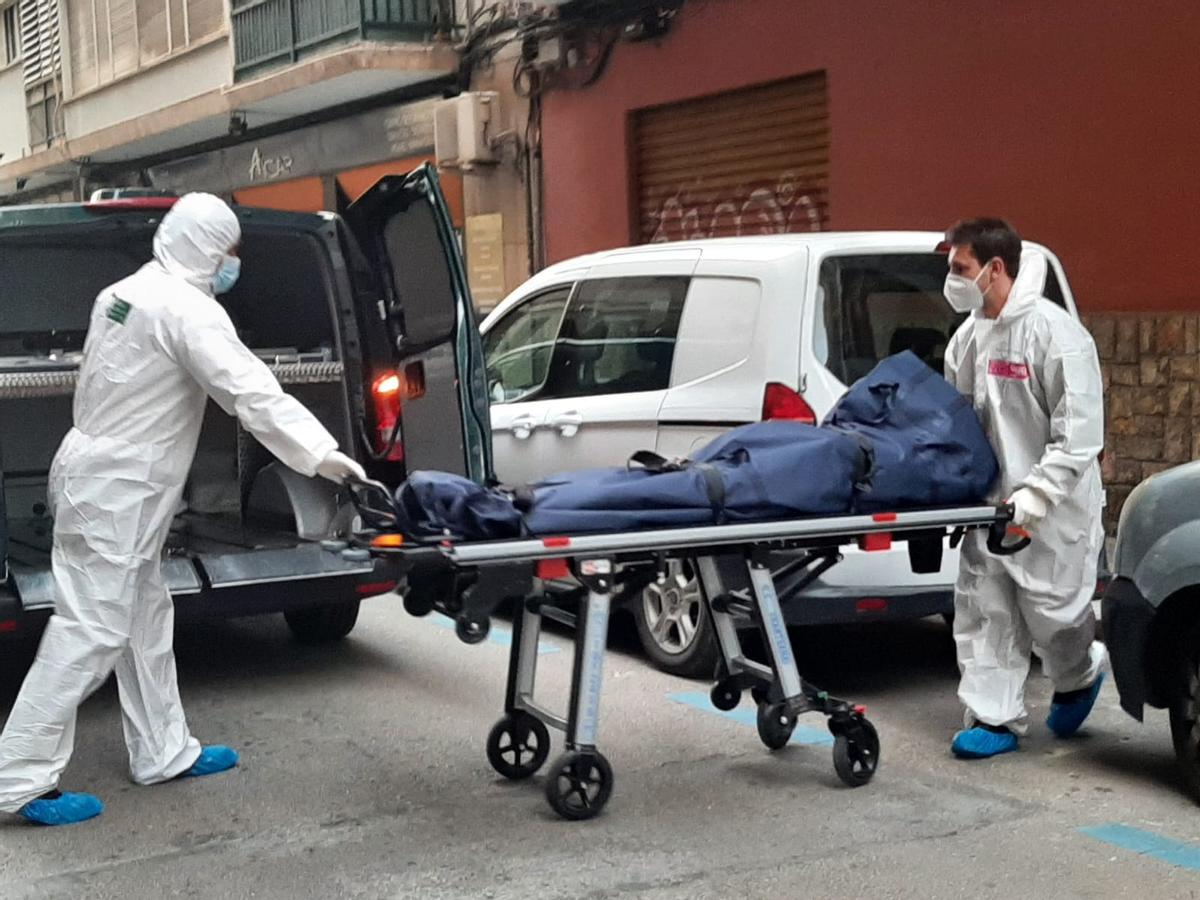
[944,218,1105,758]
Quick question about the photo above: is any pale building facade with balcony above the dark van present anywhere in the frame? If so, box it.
[0,0,461,217]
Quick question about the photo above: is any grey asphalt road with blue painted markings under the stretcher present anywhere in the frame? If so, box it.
[0,599,1200,900]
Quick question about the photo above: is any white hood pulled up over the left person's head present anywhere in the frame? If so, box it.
[154,193,241,295]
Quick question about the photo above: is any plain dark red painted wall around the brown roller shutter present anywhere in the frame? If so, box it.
[542,0,1200,312]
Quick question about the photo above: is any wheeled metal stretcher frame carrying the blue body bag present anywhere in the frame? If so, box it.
[342,482,1028,820]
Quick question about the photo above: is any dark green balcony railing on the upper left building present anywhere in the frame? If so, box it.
[232,0,454,80]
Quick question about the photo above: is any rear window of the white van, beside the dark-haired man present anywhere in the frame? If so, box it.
[814,253,1063,384]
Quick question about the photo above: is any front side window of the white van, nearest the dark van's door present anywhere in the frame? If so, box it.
[484,286,571,403]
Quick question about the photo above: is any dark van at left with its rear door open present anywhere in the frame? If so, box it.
[0,166,492,642]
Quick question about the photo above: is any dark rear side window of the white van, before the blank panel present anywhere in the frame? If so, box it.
[538,277,689,400]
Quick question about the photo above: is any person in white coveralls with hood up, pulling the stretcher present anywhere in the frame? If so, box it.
[0,193,364,824]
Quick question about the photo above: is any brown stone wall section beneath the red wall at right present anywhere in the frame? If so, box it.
[1084,314,1200,532]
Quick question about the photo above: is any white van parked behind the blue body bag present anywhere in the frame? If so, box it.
[482,232,1078,674]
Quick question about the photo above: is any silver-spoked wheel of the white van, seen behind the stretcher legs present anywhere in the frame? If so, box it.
[632,559,719,678]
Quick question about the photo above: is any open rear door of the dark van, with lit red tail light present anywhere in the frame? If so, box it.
[344,164,491,482]
